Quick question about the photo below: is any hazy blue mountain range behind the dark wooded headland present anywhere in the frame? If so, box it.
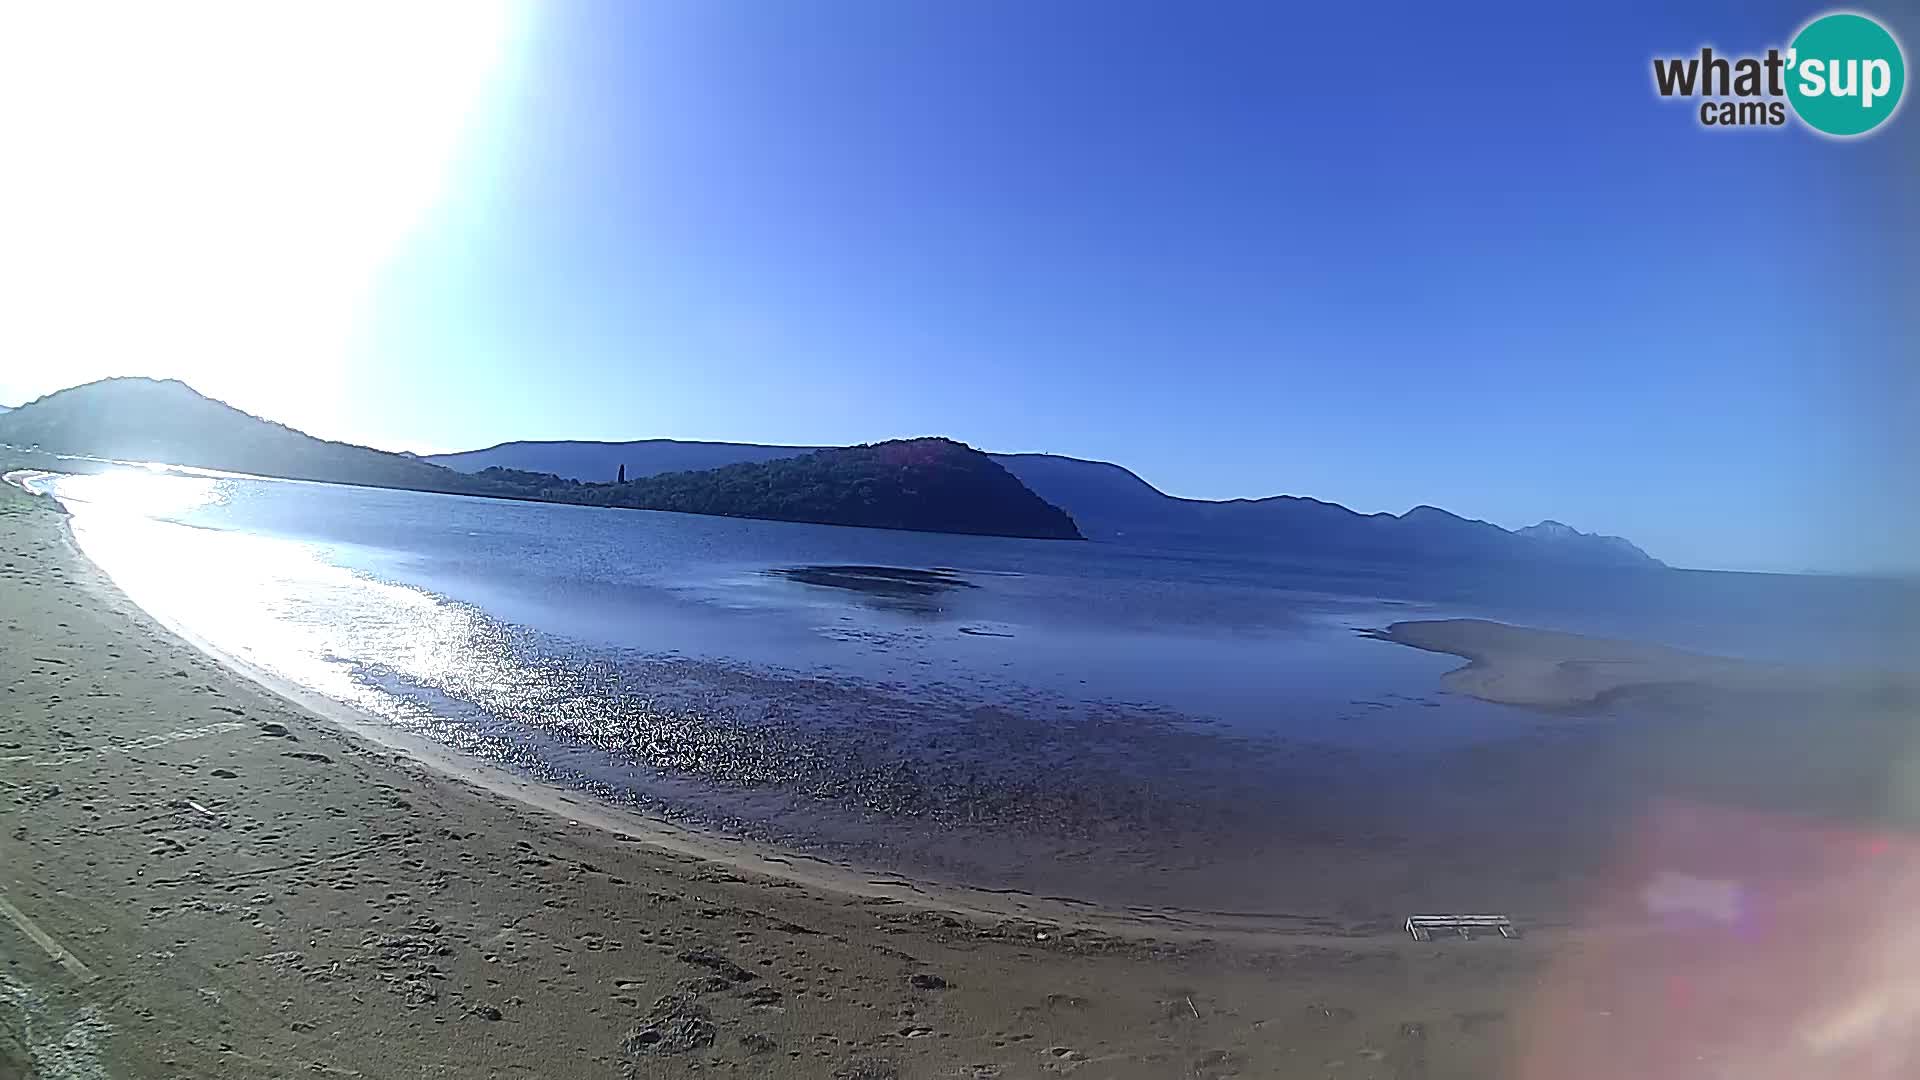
[424,438,1665,567]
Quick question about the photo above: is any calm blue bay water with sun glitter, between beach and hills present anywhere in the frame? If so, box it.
[22,469,1916,907]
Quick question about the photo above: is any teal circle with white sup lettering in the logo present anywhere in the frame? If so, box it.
[1788,12,1907,138]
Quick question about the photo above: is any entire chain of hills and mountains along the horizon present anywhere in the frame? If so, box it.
[0,379,1663,567]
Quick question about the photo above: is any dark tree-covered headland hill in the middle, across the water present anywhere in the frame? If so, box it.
[560,438,1081,540]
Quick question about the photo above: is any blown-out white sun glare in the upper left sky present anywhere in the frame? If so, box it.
[0,0,520,429]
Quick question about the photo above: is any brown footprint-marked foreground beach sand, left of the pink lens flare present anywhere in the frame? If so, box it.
[0,478,1544,1080]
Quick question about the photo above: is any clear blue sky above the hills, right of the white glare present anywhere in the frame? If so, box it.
[0,0,1920,569]
